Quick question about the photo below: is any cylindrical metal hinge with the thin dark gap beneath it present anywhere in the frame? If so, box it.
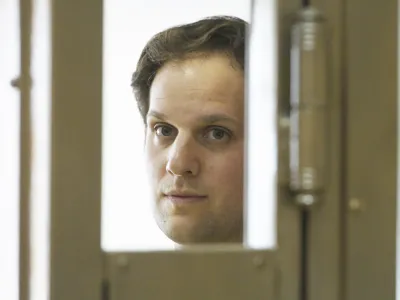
[289,2,329,300]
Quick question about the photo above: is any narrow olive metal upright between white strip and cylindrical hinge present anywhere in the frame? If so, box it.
[276,0,301,299]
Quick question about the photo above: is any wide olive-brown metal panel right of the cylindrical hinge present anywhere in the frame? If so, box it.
[308,0,399,300]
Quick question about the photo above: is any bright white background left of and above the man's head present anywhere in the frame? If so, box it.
[102,0,250,251]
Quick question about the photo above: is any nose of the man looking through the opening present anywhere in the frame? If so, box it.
[166,135,200,176]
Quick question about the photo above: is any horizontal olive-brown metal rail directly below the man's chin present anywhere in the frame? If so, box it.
[106,245,282,300]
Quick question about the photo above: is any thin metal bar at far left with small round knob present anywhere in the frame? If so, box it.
[18,0,32,300]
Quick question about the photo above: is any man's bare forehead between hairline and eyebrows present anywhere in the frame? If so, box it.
[149,55,244,118]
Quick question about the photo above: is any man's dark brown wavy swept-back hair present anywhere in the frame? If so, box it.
[131,16,248,123]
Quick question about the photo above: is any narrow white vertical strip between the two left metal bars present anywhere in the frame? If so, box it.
[29,0,51,300]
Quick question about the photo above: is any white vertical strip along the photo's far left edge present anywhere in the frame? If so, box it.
[0,0,20,300]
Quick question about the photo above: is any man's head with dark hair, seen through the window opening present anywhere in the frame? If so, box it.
[132,17,246,244]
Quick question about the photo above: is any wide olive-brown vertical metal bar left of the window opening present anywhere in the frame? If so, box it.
[50,0,103,300]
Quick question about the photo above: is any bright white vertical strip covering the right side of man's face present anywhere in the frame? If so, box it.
[245,0,278,249]
